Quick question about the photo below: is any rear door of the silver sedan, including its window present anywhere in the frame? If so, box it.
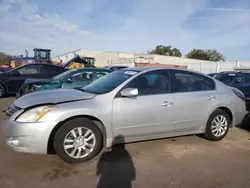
[172,70,217,132]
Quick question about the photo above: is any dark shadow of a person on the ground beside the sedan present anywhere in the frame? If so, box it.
[96,135,136,188]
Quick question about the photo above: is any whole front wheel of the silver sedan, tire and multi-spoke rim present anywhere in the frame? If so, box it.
[54,118,103,164]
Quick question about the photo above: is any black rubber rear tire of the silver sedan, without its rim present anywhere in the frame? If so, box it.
[205,109,231,141]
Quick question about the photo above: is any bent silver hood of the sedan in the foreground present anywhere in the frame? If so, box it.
[14,89,95,108]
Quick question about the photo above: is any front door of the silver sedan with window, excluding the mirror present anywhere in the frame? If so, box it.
[112,70,174,137]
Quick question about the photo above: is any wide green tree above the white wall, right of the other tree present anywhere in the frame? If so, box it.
[186,49,226,61]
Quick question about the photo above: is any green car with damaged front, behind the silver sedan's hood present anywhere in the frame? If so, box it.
[16,68,111,98]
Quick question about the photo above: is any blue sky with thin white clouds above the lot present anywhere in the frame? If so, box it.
[0,0,250,61]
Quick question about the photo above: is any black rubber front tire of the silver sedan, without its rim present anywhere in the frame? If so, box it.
[54,118,103,164]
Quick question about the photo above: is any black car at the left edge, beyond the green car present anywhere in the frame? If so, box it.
[0,63,67,98]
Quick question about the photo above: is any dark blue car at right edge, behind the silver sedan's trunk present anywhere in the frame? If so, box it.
[214,71,250,98]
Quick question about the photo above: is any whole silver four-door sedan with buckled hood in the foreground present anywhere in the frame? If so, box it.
[4,67,246,163]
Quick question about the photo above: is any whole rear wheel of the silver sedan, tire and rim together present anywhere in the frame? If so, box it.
[204,109,231,141]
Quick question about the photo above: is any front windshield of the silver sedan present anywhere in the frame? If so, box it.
[82,70,138,94]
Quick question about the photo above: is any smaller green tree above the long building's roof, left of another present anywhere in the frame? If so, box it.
[148,45,181,57]
